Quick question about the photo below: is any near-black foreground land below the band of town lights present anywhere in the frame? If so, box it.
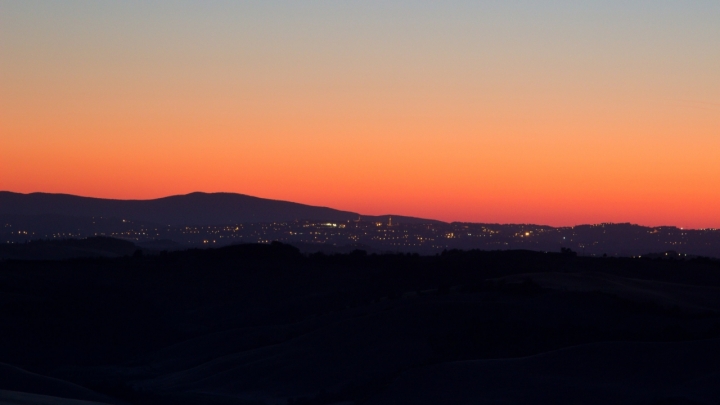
[0,243,720,405]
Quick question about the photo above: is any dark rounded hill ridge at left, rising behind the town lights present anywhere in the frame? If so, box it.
[0,191,439,225]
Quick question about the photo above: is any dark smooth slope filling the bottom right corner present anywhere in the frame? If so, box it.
[367,340,720,405]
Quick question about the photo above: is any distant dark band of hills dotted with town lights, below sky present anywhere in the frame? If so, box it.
[0,192,720,258]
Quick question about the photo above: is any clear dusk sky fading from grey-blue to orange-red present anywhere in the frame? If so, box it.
[0,0,720,228]
